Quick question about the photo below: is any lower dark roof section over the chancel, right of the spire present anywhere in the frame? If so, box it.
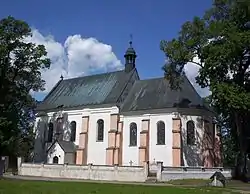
[121,76,210,112]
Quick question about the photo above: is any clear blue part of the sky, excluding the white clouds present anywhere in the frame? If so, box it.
[0,0,212,99]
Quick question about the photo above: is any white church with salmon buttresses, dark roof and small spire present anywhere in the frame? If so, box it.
[34,42,221,167]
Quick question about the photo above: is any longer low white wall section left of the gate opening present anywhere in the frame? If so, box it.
[18,158,147,182]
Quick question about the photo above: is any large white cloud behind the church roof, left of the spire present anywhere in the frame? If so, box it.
[27,29,122,93]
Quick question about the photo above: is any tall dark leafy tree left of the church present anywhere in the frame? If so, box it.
[0,16,50,159]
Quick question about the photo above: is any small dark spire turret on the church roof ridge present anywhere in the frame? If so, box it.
[124,35,136,72]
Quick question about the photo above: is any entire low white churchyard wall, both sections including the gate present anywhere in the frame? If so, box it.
[18,158,232,182]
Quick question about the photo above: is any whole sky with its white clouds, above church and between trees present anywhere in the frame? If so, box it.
[0,0,212,100]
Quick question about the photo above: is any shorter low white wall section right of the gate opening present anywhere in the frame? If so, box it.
[157,162,232,182]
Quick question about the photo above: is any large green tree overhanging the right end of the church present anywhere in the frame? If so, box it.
[160,0,250,179]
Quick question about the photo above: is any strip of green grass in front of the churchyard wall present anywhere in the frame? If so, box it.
[0,179,239,194]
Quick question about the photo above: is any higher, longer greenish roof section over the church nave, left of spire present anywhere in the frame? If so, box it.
[37,70,136,111]
